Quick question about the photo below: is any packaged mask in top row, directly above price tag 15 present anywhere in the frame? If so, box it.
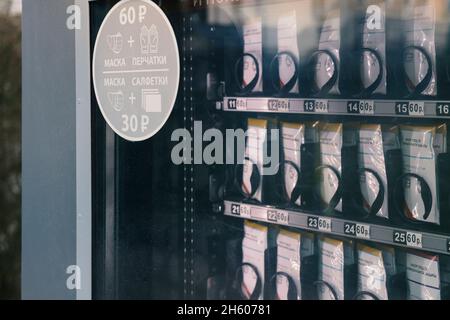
[403,0,437,96]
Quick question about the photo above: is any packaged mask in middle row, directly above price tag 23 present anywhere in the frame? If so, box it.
[319,123,343,211]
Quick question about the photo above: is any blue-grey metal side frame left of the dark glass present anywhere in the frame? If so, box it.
[22,0,92,299]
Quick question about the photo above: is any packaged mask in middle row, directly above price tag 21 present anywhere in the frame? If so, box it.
[241,119,268,202]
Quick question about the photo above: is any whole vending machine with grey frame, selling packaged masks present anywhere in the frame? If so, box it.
[22,0,450,300]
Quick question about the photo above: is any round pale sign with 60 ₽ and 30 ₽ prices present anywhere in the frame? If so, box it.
[92,0,180,141]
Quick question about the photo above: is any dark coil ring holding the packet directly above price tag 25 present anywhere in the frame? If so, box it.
[394,173,433,224]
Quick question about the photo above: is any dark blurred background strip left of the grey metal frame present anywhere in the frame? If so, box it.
[0,0,22,300]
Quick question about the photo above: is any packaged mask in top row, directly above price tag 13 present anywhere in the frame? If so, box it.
[314,4,341,94]
